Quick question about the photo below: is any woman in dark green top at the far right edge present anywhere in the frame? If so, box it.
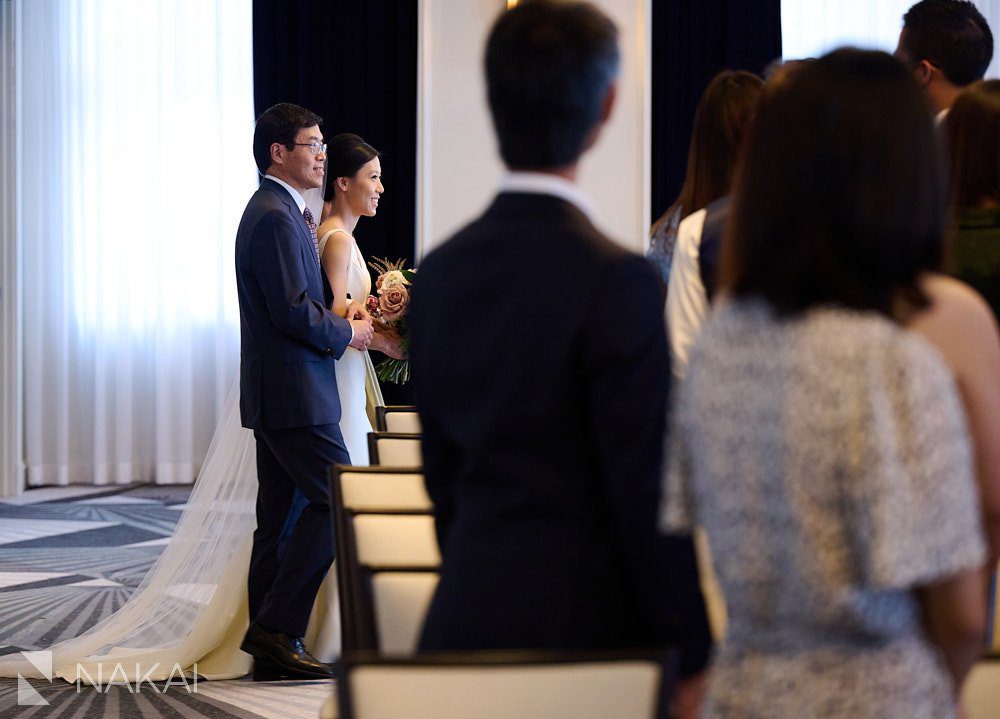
[945,80,1000,317]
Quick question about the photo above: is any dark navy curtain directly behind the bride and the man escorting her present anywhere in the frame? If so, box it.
[253,0,417,404]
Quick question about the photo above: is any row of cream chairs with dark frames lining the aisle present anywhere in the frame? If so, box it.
[330,407,676,719]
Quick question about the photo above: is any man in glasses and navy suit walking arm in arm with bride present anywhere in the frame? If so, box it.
[236,103,372,677]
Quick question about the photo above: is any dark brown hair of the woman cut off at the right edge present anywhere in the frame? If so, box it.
[945,80,1000,211]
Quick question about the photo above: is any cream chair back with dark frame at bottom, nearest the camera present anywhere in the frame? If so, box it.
[336,651,676,719]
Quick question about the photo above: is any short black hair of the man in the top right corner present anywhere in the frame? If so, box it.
[901,0,993,87]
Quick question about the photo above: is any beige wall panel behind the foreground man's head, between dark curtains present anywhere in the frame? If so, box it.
[417,0,652,256]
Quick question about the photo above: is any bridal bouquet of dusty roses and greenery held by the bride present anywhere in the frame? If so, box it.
[365,258,417,384]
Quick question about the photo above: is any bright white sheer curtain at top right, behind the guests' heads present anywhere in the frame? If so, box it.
[781,0,1000,77]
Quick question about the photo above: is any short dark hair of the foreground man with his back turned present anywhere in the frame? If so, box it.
[486,0,619,170]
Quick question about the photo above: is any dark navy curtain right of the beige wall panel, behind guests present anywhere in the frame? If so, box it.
[650,0,781,221]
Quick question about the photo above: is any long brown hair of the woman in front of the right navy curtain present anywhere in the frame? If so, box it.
[652,70,763,234]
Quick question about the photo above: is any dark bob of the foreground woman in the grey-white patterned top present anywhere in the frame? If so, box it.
[721,49,946,316]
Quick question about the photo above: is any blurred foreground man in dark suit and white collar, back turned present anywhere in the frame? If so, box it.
[410,0,711,716]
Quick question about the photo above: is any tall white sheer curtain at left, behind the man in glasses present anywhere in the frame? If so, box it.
[15,0,256,486]
